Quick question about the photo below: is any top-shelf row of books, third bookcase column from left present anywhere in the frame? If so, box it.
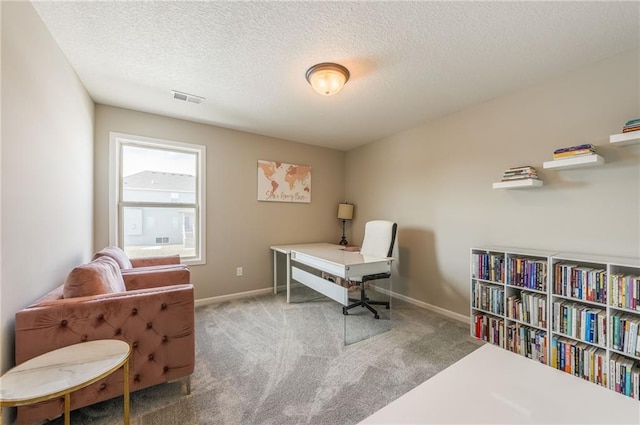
[553,262,607,304]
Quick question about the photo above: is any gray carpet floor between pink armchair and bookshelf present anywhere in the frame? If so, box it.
[50,294,480,425]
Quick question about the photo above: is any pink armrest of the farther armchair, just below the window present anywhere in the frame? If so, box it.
[121,264,191,291]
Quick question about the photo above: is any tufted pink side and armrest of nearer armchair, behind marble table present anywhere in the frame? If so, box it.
[15,284,195,362]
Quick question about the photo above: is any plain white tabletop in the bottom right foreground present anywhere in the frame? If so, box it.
[360,344,640,424]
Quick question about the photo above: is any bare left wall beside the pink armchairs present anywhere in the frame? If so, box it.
[0,1,94,371]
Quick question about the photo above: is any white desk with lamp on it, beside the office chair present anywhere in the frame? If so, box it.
[271,243,393,306]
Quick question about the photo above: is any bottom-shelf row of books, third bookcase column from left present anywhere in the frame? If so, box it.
[549,336,607,387]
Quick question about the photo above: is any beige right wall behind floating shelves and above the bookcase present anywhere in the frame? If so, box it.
[346,51,640,316]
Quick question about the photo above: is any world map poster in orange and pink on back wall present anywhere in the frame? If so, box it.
[258,159,311,203]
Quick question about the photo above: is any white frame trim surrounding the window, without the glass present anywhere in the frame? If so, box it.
[109,132,207,265]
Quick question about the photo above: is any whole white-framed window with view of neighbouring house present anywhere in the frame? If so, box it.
[109,133,206,264]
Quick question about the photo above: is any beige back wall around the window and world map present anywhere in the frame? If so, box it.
[95,103,345,299]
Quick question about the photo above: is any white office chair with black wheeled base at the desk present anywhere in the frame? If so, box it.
[342,220,398,319]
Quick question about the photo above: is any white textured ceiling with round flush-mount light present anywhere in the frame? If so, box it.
[33,1,640,150]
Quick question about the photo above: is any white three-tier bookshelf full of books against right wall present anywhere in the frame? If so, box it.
[470,246,640,400]
